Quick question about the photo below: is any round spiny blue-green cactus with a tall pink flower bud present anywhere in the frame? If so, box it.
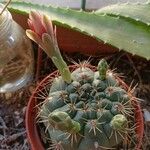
[26,12,134,150]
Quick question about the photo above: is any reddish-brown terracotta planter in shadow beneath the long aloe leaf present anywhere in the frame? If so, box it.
[12,13,117,56]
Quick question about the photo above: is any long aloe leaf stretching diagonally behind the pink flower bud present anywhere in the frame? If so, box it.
[1,2,150,59]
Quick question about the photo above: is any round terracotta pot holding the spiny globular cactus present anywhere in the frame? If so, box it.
[25,65,144,150]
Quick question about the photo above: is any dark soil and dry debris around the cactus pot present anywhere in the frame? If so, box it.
[0,52,150,150]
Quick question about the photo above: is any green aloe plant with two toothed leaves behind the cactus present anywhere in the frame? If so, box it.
[0,0,150,59]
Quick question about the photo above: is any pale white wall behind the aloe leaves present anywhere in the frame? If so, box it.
[24,0,147,9]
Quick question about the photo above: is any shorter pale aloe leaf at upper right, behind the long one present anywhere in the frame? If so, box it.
[95,3,150,25]
